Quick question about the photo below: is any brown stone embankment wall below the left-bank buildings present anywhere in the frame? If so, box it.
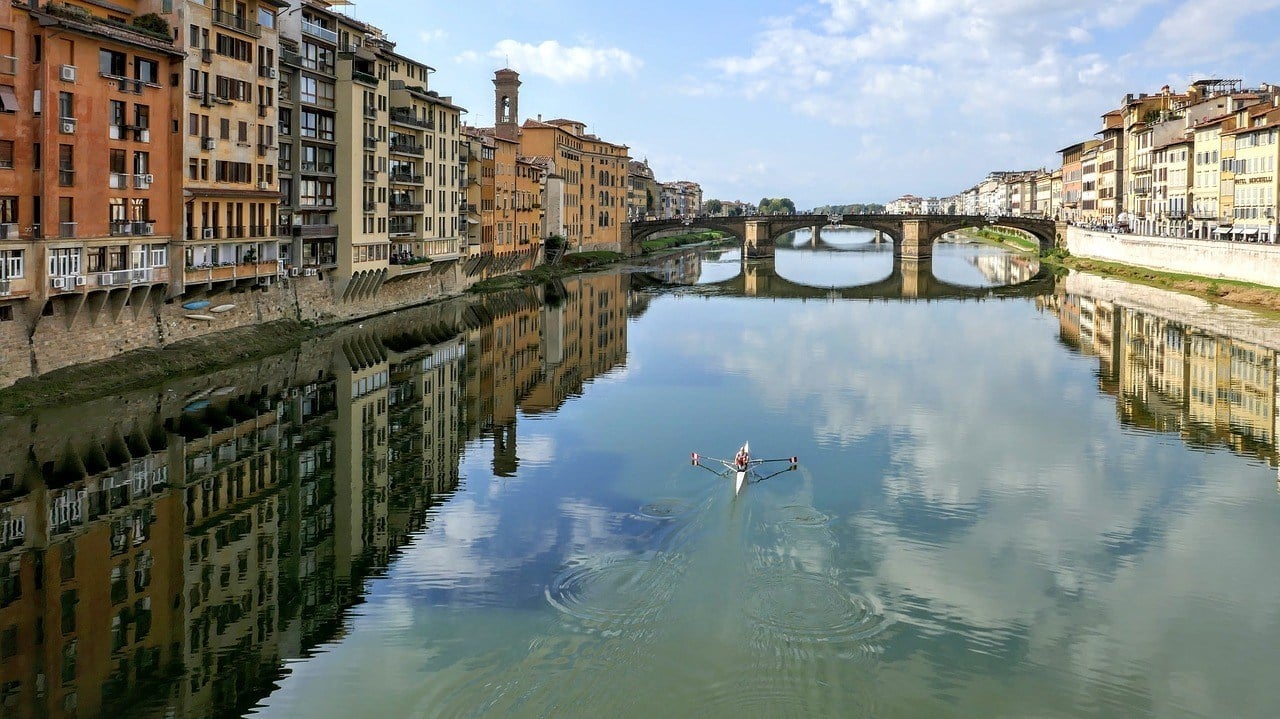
[0,262,475,388]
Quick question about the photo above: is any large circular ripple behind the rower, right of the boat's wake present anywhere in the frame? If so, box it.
[746,572,887,642]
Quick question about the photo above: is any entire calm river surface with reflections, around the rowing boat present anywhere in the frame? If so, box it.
[0,232,1280,718]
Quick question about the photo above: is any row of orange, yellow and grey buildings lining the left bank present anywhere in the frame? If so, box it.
[0,0,700,336]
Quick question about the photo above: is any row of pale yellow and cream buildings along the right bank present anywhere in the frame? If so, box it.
[886,79,1280,243]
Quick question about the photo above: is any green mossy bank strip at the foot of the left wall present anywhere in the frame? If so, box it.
[0,320,319,415]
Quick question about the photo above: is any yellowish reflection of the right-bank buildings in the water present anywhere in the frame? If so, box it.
[1056,287,1280,466]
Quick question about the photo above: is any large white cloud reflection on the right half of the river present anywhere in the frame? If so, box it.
[689,287,1280,706]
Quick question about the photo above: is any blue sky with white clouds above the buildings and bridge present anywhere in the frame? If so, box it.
[347,0,1280,209]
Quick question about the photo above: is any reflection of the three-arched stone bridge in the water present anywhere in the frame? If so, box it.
[649,249,1055,299]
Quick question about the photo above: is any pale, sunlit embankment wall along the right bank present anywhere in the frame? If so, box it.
[1066,228,1280,287]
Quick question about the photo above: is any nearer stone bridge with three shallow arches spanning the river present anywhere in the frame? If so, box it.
[622,215,1066,258]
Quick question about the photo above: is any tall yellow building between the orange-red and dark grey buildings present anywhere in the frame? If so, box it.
[156,0,288,294]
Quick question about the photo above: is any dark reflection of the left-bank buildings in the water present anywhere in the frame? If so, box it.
[0,276,627,718]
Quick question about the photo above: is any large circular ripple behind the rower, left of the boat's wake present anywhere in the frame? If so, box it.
[545,553,678,626]
